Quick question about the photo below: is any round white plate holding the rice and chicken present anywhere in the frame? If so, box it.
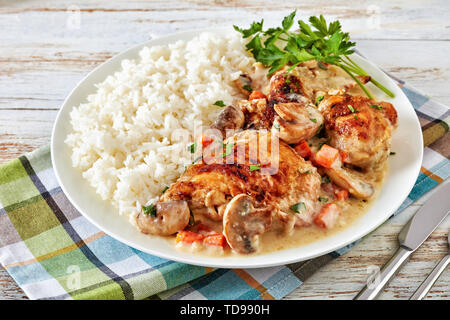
[51,29,423,268]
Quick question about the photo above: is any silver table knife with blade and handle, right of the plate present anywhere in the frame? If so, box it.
[355,181,450,300]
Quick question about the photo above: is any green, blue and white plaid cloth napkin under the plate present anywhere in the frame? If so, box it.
[0,81,450,299]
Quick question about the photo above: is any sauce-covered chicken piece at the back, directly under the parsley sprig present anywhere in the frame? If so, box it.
[269,60,370,103]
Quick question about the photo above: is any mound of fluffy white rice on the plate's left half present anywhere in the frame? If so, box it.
[66,33,255,221]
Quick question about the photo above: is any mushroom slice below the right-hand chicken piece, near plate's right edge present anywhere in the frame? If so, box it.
[325,167,375,199]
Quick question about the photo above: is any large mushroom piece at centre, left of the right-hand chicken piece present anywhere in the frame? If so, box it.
[272,102,323,144]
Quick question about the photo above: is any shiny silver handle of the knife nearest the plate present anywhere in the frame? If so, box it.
[354,247,412,300]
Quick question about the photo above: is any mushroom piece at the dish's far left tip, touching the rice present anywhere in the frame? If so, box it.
[136,200,190,236]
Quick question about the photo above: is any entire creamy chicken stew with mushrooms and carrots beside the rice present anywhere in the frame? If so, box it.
[136,61,397,255]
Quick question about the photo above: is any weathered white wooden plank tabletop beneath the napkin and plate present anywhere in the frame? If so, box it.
[0,0,450,299]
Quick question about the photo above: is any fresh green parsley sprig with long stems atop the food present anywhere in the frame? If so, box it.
[233,11,394,98]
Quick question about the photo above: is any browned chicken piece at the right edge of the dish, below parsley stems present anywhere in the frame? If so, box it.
[319,95,397,168]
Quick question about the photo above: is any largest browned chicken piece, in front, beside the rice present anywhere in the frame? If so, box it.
[160,130,321,250]
